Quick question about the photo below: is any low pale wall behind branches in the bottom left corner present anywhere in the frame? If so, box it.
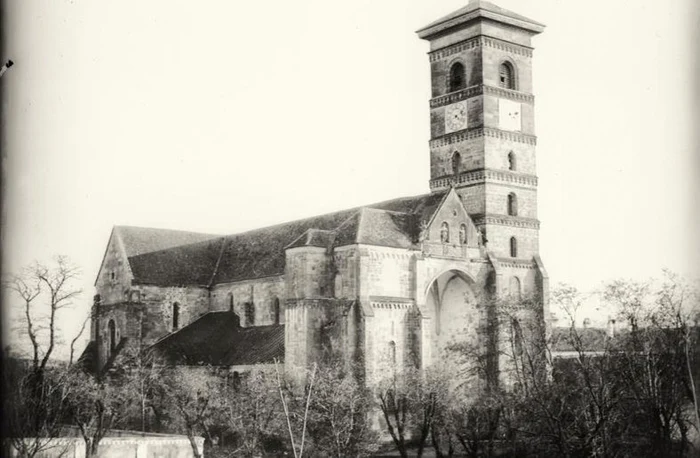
[10,431,204,458]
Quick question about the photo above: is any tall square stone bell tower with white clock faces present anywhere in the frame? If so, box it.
[417,0,544,261]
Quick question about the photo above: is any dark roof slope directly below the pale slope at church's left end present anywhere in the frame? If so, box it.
[129,238,223,286]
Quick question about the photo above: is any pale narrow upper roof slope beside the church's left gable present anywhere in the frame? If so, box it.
[114,226,221,257]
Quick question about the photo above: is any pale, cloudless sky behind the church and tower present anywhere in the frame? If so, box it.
[1,0,700,356]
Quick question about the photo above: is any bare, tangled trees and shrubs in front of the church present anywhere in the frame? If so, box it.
[3,258,700,458]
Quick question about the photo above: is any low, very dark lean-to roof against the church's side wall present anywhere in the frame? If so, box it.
[151,312,284,366]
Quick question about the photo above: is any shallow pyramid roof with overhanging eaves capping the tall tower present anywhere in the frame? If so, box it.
[417,0,544,38]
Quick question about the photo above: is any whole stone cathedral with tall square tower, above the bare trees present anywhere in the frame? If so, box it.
[86,0,548,381]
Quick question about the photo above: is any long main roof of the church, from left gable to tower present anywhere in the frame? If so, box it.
[115,193,446,286]
